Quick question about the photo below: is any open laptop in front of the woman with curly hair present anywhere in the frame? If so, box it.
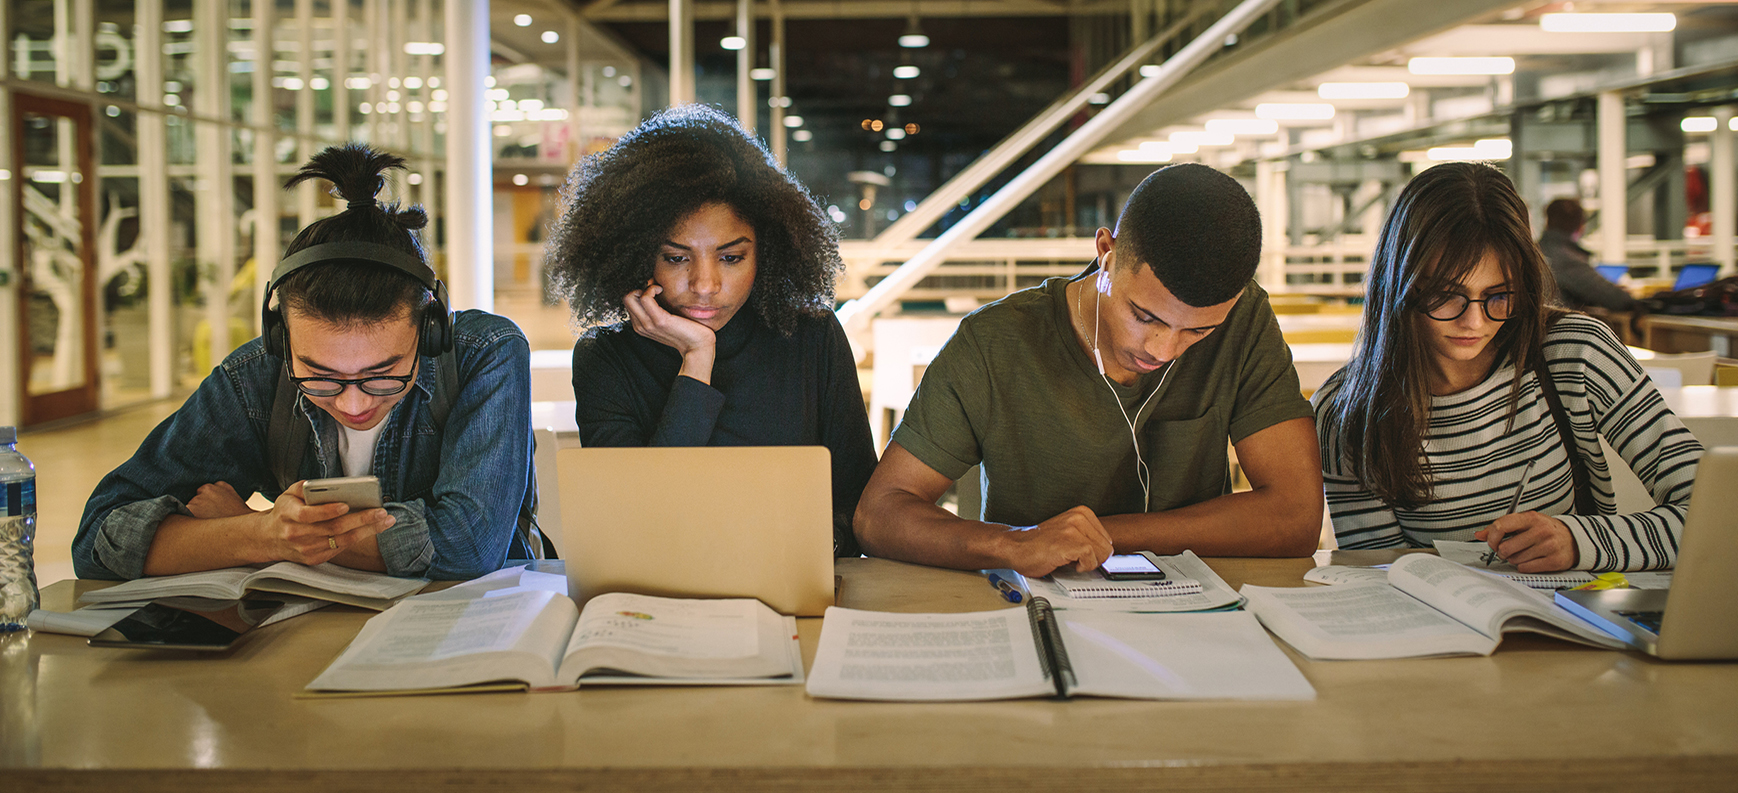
[556,447,833,617]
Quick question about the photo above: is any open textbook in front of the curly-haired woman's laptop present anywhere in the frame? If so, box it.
[308,586,803,694]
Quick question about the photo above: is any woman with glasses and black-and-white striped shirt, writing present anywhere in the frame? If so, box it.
[1312,163,1702,572]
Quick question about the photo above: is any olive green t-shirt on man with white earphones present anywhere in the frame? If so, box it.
[893,271,1312,525]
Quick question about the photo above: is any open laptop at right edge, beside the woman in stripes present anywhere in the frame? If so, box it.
[1557,447,1738,659]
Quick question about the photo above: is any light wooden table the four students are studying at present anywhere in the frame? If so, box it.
[0,551,1738,793]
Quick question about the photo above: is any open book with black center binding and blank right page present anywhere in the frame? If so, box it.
[808,598,1316,701]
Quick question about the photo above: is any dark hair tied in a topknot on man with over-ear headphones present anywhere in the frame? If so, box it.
[276,143,433,327]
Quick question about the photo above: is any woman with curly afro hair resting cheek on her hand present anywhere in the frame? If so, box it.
[544,104,876,556]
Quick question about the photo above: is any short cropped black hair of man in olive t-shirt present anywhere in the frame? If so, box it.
[1116,163,1262,308]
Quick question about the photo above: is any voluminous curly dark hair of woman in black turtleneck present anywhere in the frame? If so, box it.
[544,104,845,336]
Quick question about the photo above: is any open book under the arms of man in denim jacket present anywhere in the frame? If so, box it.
[78,562,428,610]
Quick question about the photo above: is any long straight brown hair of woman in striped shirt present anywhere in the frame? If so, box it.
[1321,162,1556,508]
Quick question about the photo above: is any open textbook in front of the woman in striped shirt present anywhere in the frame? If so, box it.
[1243,553,1625,661]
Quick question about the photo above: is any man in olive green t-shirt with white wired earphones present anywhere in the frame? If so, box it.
[855,163,1323,576]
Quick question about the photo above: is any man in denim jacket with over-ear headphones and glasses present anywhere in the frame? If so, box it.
[73,144,541,579]
